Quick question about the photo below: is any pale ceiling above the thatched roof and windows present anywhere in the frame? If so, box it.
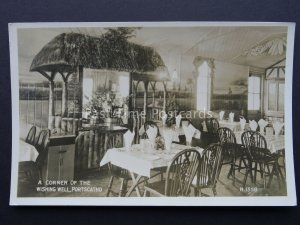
[18,25,287,81]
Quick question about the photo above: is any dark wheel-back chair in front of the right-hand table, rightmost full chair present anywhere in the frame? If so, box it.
[241,131,281,188]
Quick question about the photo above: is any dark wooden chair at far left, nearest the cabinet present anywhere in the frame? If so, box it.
[19,130,50,183]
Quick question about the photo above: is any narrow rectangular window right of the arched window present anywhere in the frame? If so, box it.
[248,75,261,110]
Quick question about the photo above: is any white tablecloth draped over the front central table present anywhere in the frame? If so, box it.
[100,144,203,177]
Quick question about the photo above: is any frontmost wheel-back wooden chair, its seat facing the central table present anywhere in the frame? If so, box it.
[144,149,201,197]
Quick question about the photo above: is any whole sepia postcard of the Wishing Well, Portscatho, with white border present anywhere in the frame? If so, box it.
[9,22,297,206]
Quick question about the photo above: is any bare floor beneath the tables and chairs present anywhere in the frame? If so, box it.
[18,165,287,197]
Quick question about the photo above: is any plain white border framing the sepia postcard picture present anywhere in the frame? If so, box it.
[9,22,297,206]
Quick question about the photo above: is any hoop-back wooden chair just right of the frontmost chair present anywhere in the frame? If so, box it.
[193,143,222,196]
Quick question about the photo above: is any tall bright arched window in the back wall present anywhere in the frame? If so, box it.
[196,62,211,110]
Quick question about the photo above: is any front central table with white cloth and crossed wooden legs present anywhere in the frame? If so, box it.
[100,143,204,197]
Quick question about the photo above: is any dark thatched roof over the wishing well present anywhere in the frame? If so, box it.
[30,33,169,79]
